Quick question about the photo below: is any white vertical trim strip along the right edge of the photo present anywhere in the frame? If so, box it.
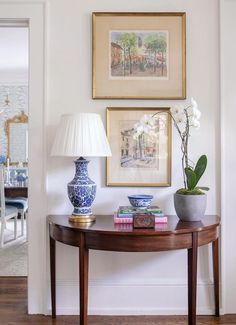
[221,0,236,313]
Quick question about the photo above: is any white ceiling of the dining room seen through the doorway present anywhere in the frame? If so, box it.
[0,27,28,71]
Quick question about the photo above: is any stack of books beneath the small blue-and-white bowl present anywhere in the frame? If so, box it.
[114,206,167,224]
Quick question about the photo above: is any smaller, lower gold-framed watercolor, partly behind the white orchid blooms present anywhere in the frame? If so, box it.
[107,107,171,186]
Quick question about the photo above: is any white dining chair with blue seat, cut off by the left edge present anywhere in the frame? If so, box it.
[0,165,18,247]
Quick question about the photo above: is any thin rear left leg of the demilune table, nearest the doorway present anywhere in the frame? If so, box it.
[50,236,56,318]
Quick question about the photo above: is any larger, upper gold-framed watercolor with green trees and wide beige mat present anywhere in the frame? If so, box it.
[93,12,186,99]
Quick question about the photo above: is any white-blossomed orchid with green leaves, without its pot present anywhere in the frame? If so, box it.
[134,98,209,195]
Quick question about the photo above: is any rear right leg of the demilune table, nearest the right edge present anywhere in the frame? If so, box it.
[212,238,220,317]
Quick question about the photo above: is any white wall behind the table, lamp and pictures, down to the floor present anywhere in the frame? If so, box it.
[46,0,220,314]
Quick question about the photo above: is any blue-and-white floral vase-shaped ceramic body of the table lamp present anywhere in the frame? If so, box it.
[68,157,96,215]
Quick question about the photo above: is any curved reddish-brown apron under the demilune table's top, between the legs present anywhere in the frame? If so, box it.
[50,224,218,252]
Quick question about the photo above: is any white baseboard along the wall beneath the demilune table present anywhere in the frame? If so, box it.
[46,279,218,315]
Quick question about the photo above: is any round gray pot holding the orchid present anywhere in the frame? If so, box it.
[174,193,206,221]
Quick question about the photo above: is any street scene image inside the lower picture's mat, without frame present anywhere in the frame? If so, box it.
[119,120,159,169]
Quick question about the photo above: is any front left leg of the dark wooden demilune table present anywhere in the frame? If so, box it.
[79,233,89,325]
